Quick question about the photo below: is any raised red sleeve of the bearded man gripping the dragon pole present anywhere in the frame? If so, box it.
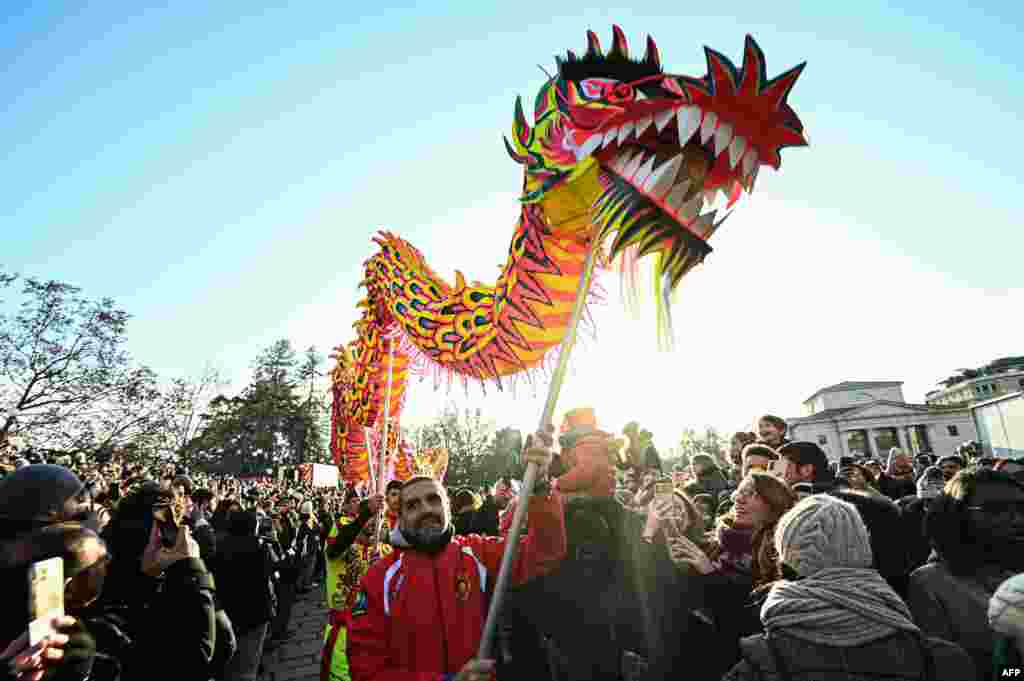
[463,495,567,585]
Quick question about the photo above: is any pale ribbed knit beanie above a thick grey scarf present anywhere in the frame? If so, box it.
[775,495,871,577]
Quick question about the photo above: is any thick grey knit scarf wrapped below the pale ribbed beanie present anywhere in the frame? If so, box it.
[761,567,921,647]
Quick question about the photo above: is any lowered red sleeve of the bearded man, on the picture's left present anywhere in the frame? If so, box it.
[346,569,444,681]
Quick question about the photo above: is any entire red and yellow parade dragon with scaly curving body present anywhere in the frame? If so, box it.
[331,27,808,480]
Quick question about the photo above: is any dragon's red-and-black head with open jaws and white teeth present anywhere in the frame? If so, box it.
[505,26,808,291]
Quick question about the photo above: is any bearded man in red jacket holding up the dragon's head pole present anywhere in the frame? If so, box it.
[348,433,565,681]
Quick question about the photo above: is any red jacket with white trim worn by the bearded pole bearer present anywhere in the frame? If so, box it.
[348,495,566,681]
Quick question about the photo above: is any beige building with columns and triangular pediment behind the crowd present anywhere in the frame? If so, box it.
[786,381,978,461]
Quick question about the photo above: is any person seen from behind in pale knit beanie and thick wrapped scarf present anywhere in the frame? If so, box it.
[723,495,977,681]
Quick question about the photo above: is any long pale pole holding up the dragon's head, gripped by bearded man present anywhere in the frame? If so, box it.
[476,238,598,659]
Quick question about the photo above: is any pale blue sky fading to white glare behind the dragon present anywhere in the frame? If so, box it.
[0,2,1024,444]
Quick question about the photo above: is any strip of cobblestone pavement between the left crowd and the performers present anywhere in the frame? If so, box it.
[259,589,327,681]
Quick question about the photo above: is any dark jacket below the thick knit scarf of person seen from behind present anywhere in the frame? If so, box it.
[722,634,984,681]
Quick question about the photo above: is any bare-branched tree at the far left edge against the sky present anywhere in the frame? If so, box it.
[0,272,156,449]
